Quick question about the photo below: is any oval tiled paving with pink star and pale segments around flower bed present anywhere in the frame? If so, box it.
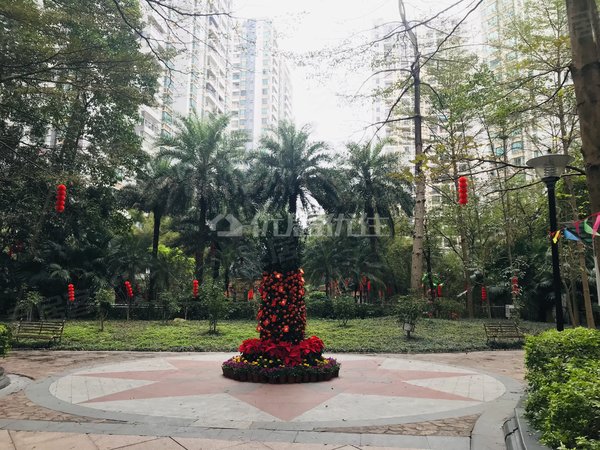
[50,354,505,428]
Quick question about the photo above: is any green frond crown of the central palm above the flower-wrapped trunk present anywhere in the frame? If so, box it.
[252,122,337,216]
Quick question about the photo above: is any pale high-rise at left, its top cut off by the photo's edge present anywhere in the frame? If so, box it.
[137,0,232,154]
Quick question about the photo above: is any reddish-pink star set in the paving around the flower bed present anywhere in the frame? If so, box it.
[76,359,479,421]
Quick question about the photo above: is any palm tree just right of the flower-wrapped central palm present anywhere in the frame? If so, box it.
[345,140,414,249]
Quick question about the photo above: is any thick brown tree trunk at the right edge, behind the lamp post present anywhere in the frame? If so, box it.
[566,0,600,307]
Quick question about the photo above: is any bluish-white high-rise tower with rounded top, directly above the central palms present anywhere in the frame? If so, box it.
[230,20,292,148]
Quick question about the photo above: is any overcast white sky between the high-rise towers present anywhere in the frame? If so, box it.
[233,0,470,151]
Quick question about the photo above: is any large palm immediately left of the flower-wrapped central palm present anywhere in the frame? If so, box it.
[157,114,243,280]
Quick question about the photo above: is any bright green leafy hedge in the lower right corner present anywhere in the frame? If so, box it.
[525,328,600,450]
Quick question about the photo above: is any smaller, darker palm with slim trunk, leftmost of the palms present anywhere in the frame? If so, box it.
[122,158,186,300]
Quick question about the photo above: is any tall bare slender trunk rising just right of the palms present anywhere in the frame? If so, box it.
[398,0,425,293]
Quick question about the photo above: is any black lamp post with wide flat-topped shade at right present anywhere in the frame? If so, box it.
[527,153,573,331]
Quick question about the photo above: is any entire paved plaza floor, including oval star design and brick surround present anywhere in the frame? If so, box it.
[0,351,523,450]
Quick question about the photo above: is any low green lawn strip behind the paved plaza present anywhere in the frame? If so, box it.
[10,317,553,353]
